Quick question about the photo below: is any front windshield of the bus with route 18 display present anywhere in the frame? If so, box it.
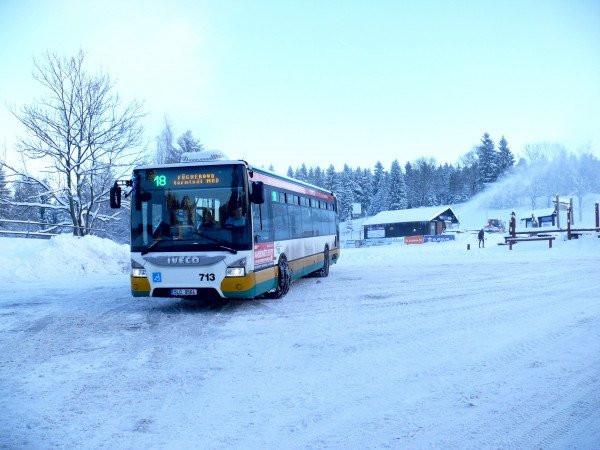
[131,164,252,253]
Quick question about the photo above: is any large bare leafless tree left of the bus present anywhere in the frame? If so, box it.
[3,51,143,236]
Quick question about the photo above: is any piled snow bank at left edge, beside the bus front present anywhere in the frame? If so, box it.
[0,235,130,284]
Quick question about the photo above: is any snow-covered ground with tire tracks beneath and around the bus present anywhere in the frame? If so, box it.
[0,237,600,449]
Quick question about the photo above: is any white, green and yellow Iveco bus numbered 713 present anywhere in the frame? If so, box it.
[110,158,340,299]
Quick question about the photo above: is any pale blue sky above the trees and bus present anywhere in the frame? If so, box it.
[0,0,600,170]
